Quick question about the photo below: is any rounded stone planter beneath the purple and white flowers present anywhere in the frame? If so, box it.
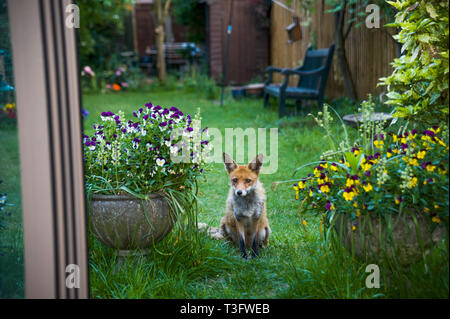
[90,194,175,256]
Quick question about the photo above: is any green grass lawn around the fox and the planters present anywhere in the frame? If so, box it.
[83,90,449,298]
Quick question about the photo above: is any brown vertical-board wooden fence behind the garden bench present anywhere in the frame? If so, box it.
[270,0,397,99]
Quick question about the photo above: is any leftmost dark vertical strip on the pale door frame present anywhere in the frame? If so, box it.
[38,0,61,298]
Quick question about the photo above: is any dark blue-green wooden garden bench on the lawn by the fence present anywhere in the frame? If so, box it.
[264,44,334,117]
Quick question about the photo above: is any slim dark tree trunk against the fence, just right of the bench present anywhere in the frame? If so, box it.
[334,0,358,100]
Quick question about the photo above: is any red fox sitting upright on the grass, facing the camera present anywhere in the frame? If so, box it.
[220,153,271,258]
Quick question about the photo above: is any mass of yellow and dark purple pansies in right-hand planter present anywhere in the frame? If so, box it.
[294,127,448,229]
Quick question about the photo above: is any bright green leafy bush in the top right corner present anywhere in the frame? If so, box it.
[380,0,449,126]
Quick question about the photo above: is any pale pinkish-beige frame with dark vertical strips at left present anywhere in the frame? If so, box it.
[8,0,89,298]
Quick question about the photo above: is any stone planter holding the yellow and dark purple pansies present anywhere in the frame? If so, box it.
[334,211,448,266]
